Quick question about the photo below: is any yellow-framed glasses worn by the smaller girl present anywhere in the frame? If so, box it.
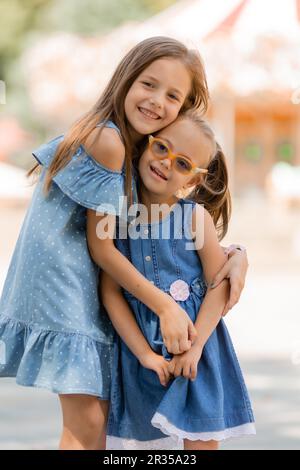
[149,135,207,175]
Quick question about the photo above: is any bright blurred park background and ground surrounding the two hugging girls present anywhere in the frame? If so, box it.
[0,0,300,449]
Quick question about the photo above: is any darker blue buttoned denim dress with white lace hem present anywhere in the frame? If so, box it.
[108,199,255,448]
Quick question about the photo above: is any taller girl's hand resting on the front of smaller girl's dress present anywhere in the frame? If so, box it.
[159,300,197,354]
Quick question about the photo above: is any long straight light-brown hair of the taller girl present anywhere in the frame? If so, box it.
[28,36,209,199]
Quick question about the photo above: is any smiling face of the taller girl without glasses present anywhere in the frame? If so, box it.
[125,58,191,136]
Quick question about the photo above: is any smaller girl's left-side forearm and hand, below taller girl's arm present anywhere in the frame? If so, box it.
[101,271,170,385]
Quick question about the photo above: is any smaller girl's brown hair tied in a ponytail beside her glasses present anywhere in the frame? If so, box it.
[182,111,231,240]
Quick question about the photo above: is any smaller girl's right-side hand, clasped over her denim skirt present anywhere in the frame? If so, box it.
[168,345,202,380]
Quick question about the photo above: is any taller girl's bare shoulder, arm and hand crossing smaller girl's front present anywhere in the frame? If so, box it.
[85,127,196,354]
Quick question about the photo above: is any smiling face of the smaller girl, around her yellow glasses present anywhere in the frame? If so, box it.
[139,117,213,201]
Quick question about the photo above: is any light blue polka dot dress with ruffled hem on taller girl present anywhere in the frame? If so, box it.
[0,122,124,399]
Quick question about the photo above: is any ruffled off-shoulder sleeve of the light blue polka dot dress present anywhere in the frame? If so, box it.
[32,135,125,215]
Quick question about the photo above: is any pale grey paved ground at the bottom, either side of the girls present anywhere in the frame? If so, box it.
[0,359,300,450]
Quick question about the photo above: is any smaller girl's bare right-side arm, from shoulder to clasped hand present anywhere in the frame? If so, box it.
[169,206,229,379]
